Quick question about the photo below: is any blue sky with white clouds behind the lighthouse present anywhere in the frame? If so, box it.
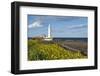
[28,15,88,38]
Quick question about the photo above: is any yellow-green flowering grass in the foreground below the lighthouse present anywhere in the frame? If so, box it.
[28,40,86,60]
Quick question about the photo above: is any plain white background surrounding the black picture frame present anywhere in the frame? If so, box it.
[0,0,100,76]
